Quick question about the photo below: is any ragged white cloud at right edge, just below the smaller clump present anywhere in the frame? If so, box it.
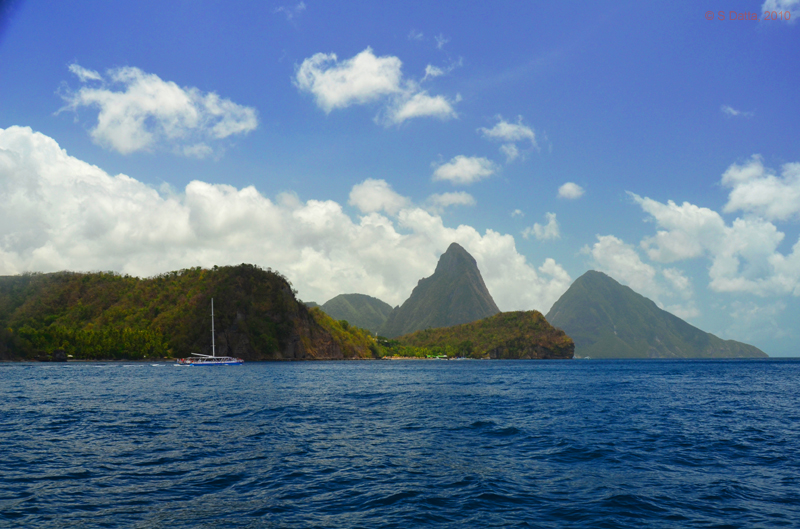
[631,190,800,296]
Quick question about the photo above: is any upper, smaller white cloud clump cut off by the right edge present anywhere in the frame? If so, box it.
[722,156,800,220]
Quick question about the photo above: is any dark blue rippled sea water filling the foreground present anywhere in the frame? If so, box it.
[0,360,800,529]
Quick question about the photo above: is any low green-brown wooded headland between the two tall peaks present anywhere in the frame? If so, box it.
[397,310,575,359]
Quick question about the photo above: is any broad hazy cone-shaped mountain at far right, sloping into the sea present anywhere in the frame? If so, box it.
[547,270,767,358]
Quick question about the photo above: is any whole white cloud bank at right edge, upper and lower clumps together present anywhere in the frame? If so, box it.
[630,156,800,297]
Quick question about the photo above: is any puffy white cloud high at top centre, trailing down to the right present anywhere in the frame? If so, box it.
[295,48,456,125]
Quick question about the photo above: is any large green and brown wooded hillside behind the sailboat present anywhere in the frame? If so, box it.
[0,264,375,360]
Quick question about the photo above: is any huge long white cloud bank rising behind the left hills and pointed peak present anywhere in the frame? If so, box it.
[0,127,570,312]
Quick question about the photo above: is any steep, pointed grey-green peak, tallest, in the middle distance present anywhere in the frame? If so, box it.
[380,243,500,338]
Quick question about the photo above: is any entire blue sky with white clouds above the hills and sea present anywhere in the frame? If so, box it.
[0,0,800,356]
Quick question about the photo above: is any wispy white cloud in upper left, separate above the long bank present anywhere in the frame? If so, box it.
[59,64,258,156]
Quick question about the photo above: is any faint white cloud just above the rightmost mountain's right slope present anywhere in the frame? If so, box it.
[583,235,699,318]
